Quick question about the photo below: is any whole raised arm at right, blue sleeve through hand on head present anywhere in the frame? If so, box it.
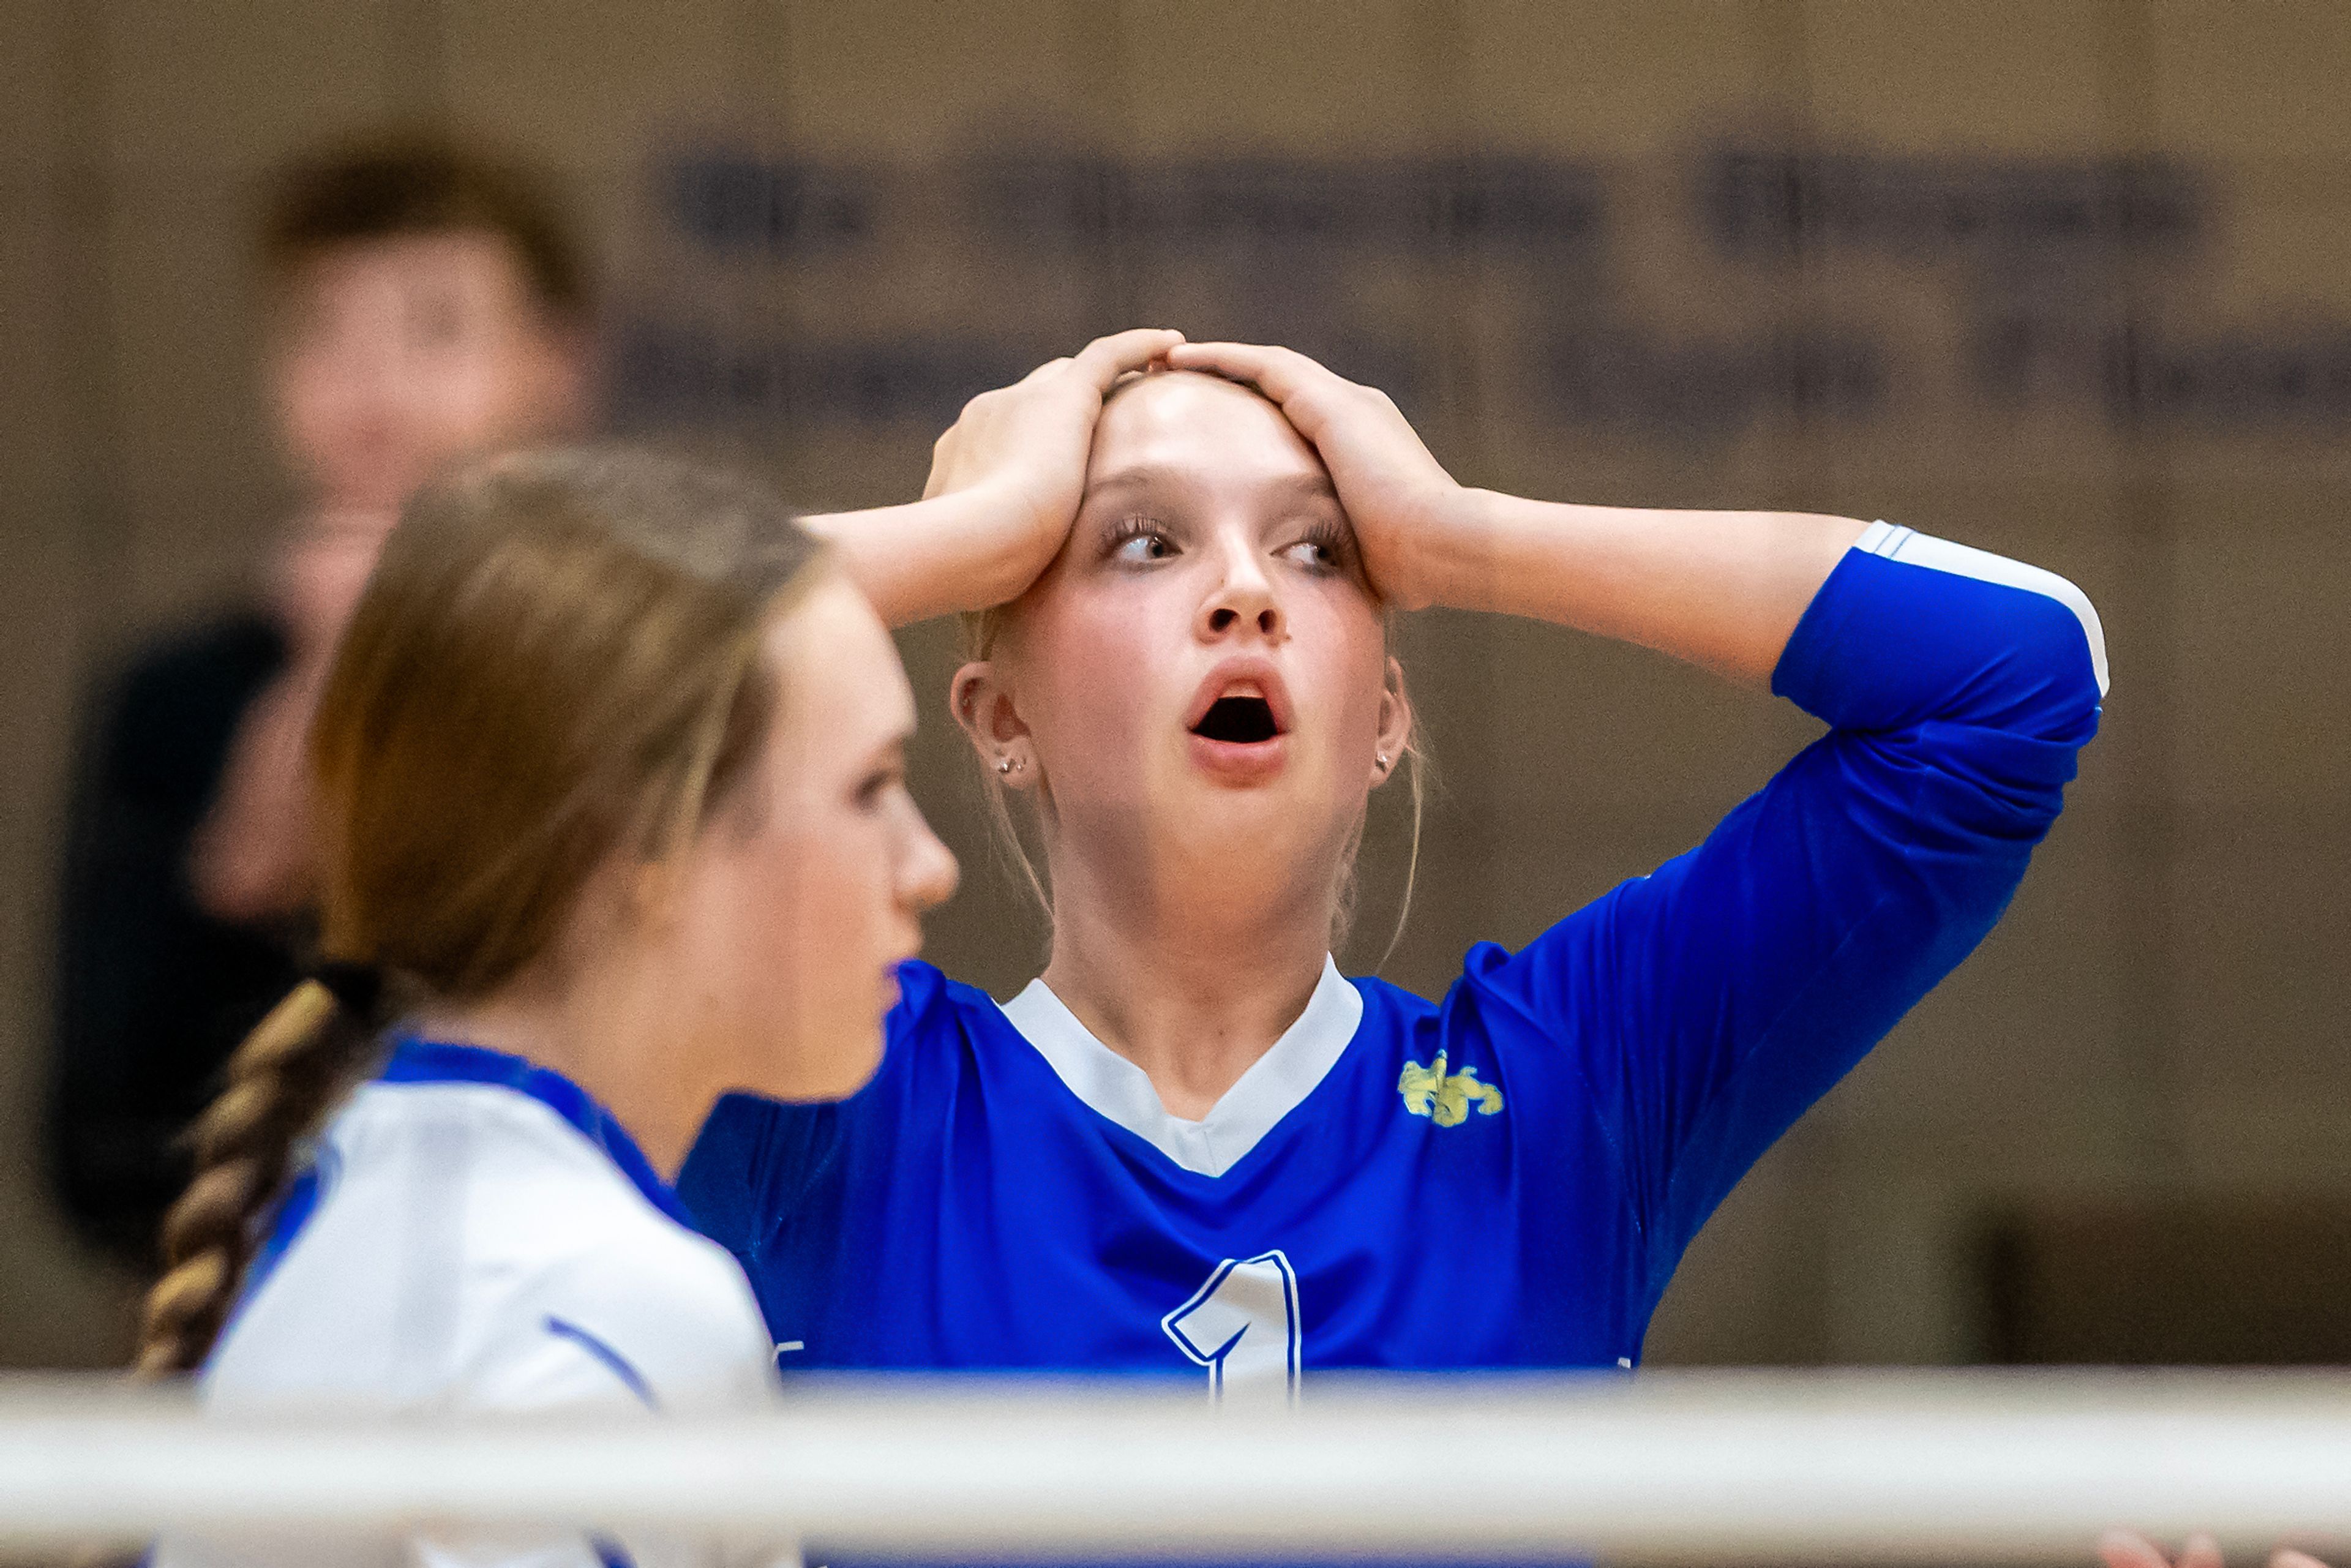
[1171,345,2107,1319]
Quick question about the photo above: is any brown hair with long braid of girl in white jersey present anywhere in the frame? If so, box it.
[139,449,818,1373]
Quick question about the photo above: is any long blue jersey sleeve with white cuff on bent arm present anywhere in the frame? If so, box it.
[1462,524,2104,1305]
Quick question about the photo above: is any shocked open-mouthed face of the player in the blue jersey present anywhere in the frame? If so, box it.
[959,373,1408,921]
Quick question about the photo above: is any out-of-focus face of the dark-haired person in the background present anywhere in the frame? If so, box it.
[268,233,583,512]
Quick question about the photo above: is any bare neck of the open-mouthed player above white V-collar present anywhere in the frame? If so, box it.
[1044,846,1335,1121]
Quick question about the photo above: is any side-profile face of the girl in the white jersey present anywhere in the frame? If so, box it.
[666,576,957,1100]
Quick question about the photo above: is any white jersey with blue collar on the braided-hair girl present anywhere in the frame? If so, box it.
[155,1041,776,1568]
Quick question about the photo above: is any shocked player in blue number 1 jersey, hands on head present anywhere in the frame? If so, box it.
[682,334,2107,1401]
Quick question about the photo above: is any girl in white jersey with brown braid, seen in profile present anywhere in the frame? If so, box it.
[143,451,954,1568]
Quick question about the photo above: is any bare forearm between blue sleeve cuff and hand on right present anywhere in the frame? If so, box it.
[1427,491,1867,686]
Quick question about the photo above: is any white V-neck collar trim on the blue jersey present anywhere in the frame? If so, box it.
[1004,955,1363,1176]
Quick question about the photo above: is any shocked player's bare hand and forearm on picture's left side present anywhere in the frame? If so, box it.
[801,327,1183,625]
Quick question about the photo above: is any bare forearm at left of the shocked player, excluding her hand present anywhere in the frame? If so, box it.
[818,489,1035,628]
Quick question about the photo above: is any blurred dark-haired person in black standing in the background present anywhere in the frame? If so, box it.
[47,139,590,1272]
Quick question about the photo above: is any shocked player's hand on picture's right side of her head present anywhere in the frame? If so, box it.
[1166,343,1467,609]
